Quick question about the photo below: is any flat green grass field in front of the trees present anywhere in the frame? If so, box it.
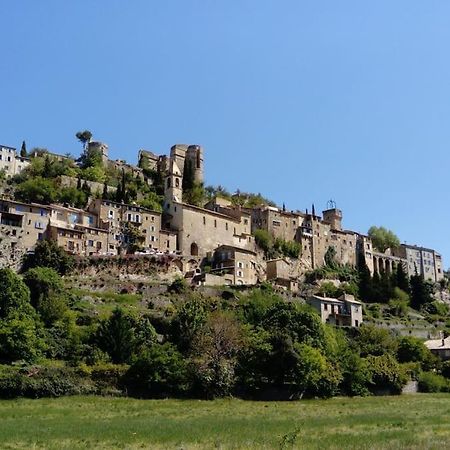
[0,394,450,449]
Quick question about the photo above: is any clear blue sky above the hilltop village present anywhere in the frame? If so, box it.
[0,0,450,267]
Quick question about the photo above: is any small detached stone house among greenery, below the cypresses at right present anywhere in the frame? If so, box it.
[307,294,363,327]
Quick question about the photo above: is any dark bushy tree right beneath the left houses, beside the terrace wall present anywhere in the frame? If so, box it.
[22,239,75,275]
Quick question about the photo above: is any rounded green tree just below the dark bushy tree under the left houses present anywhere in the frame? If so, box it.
[23,267,68,325]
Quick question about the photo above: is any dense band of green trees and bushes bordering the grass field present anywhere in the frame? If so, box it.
[0,246,450,398]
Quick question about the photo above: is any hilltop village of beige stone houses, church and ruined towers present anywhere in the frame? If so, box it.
[0,139,444,292]
